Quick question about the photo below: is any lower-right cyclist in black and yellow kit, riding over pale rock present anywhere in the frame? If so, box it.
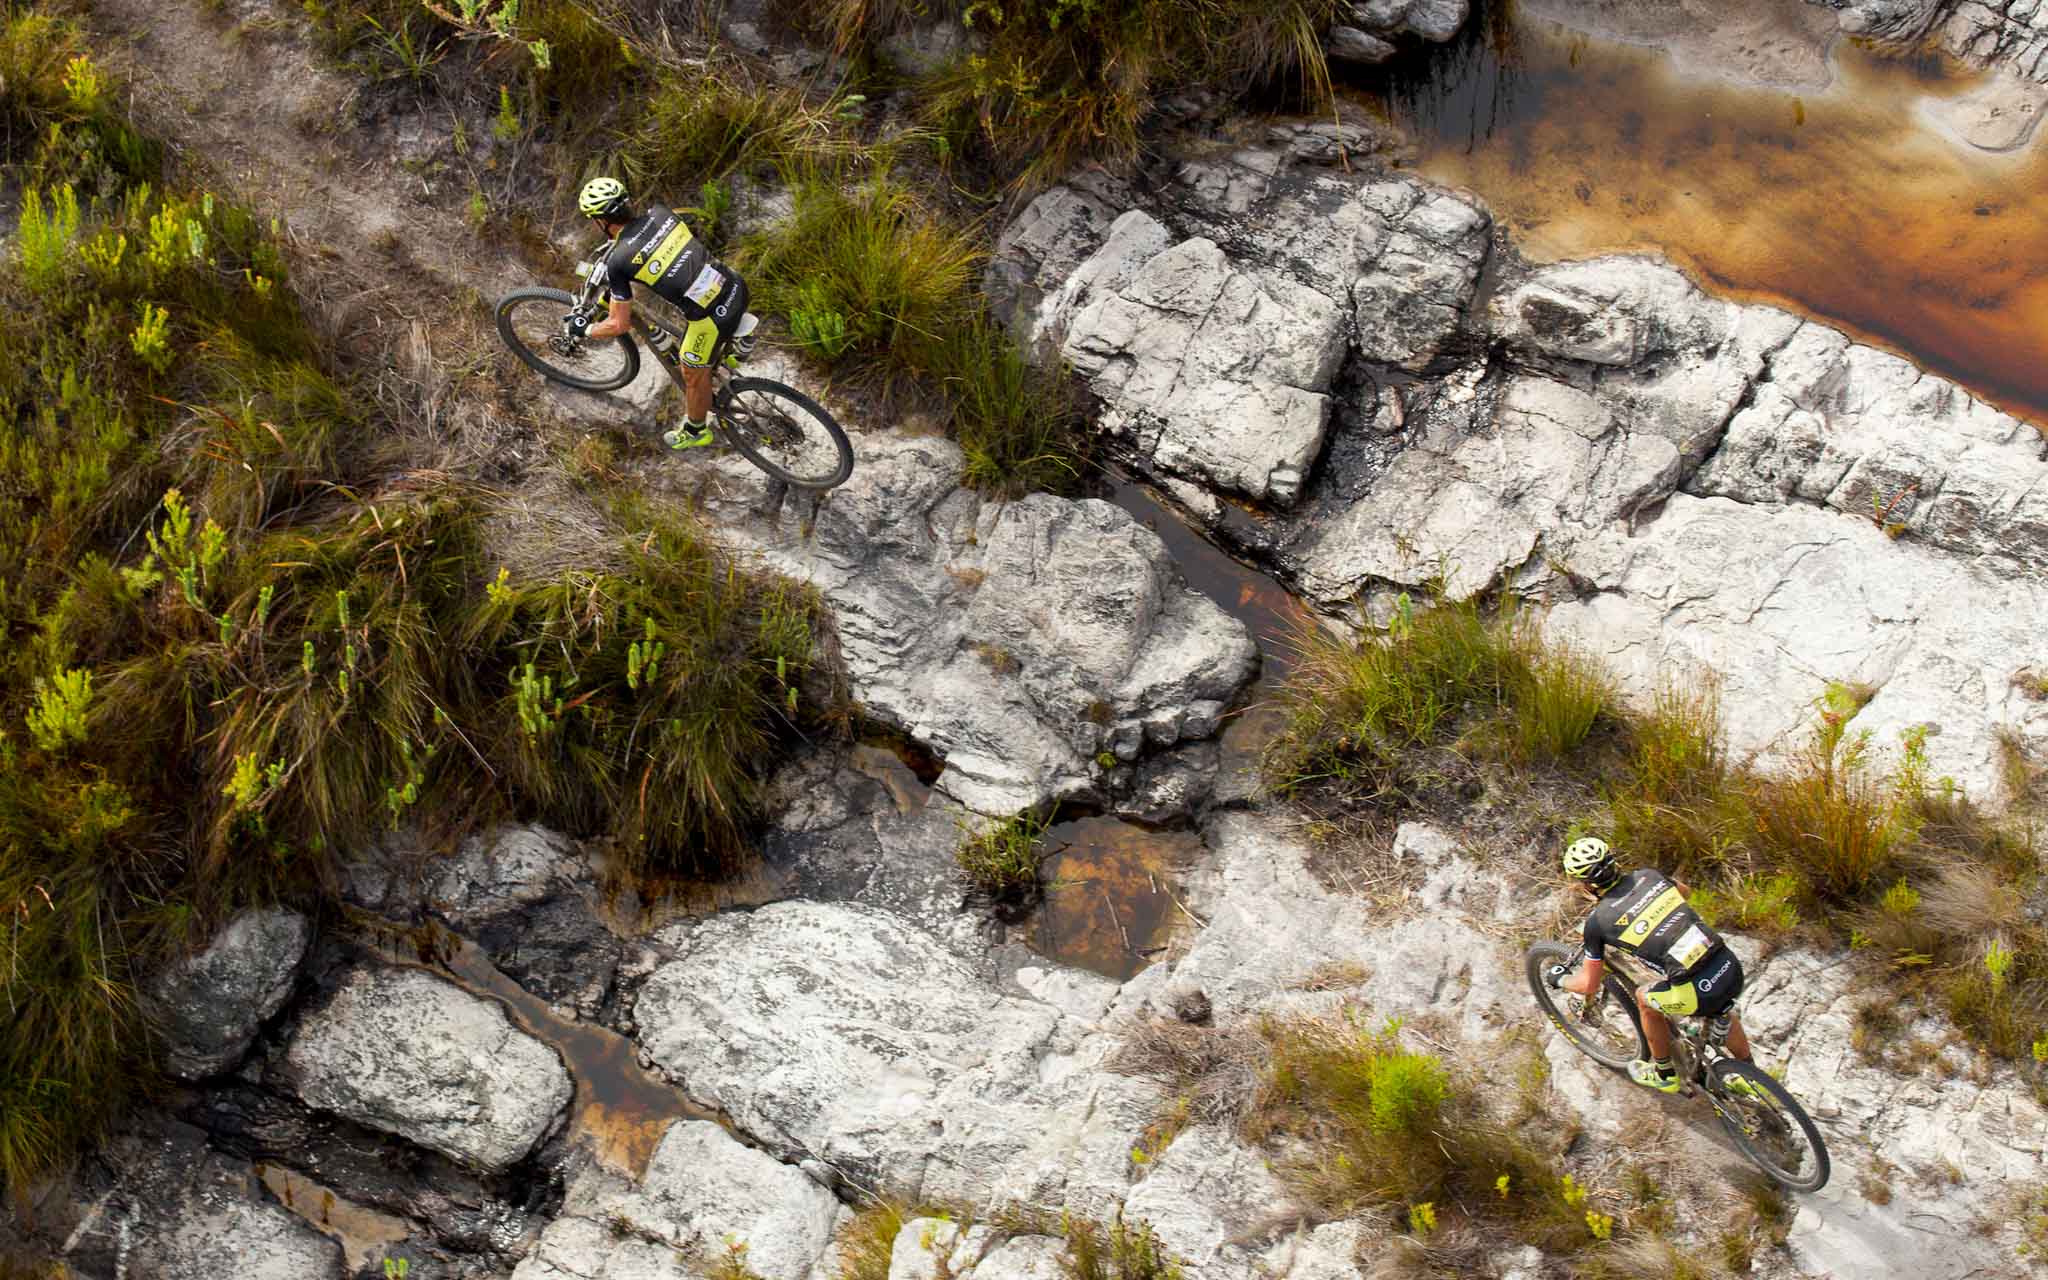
[1550,836,1749,1094]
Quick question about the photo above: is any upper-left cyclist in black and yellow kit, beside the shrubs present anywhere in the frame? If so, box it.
[575,178,760,449]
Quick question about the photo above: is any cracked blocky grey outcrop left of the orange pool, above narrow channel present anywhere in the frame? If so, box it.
[1018,164,1489,508]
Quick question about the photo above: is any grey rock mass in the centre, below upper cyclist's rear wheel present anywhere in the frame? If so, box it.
[696,436,1257,813]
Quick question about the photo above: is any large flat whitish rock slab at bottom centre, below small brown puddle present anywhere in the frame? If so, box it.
[637,903,1157,1212]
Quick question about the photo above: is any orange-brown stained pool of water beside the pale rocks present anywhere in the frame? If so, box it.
[1397,20,2048,424]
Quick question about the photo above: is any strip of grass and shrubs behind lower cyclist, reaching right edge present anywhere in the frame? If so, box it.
[1268,602,2048,1059]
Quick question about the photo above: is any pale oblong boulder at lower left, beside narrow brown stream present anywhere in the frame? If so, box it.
[276,969,571,1171]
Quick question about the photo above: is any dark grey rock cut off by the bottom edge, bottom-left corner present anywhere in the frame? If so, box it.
[49,1124,346,1280]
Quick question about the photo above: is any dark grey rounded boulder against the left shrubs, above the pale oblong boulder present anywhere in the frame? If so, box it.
[147,909,313,1079]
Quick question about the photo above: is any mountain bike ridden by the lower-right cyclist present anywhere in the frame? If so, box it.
[1522,942,1829,1192]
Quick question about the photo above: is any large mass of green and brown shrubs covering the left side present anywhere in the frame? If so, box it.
[0,10,836,1190]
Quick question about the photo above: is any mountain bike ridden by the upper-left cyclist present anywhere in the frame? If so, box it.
[496,244,854,489]
